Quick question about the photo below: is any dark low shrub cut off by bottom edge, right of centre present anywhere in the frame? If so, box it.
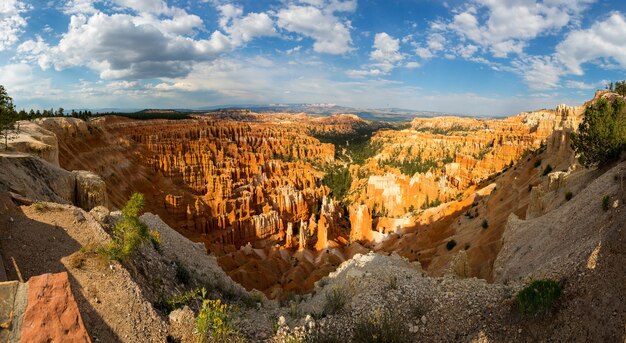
[352,311,414,343]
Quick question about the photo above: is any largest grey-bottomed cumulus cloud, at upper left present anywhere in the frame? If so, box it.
[18,12,231,79]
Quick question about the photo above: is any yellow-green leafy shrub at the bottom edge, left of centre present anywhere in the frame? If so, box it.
[196,299,236,342]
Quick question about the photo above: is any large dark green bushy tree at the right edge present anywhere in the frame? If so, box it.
[572,99,626,167]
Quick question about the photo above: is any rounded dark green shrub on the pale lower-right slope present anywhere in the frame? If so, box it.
[515,280,561,315]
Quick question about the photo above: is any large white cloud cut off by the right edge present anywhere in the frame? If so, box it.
[556,12,626,75]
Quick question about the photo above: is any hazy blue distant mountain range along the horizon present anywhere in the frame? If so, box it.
[86,104,470,122]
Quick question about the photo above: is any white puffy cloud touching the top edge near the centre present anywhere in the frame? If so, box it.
[276,0,356,55]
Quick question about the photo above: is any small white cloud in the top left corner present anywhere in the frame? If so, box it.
[0,0,29,51]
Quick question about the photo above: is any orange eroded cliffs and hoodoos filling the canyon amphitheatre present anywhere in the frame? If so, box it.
[41,99,582,297]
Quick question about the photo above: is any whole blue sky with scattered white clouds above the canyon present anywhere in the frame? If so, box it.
[0,0,626,116]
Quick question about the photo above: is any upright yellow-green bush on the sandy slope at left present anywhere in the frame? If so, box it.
[100,193,160,261]
